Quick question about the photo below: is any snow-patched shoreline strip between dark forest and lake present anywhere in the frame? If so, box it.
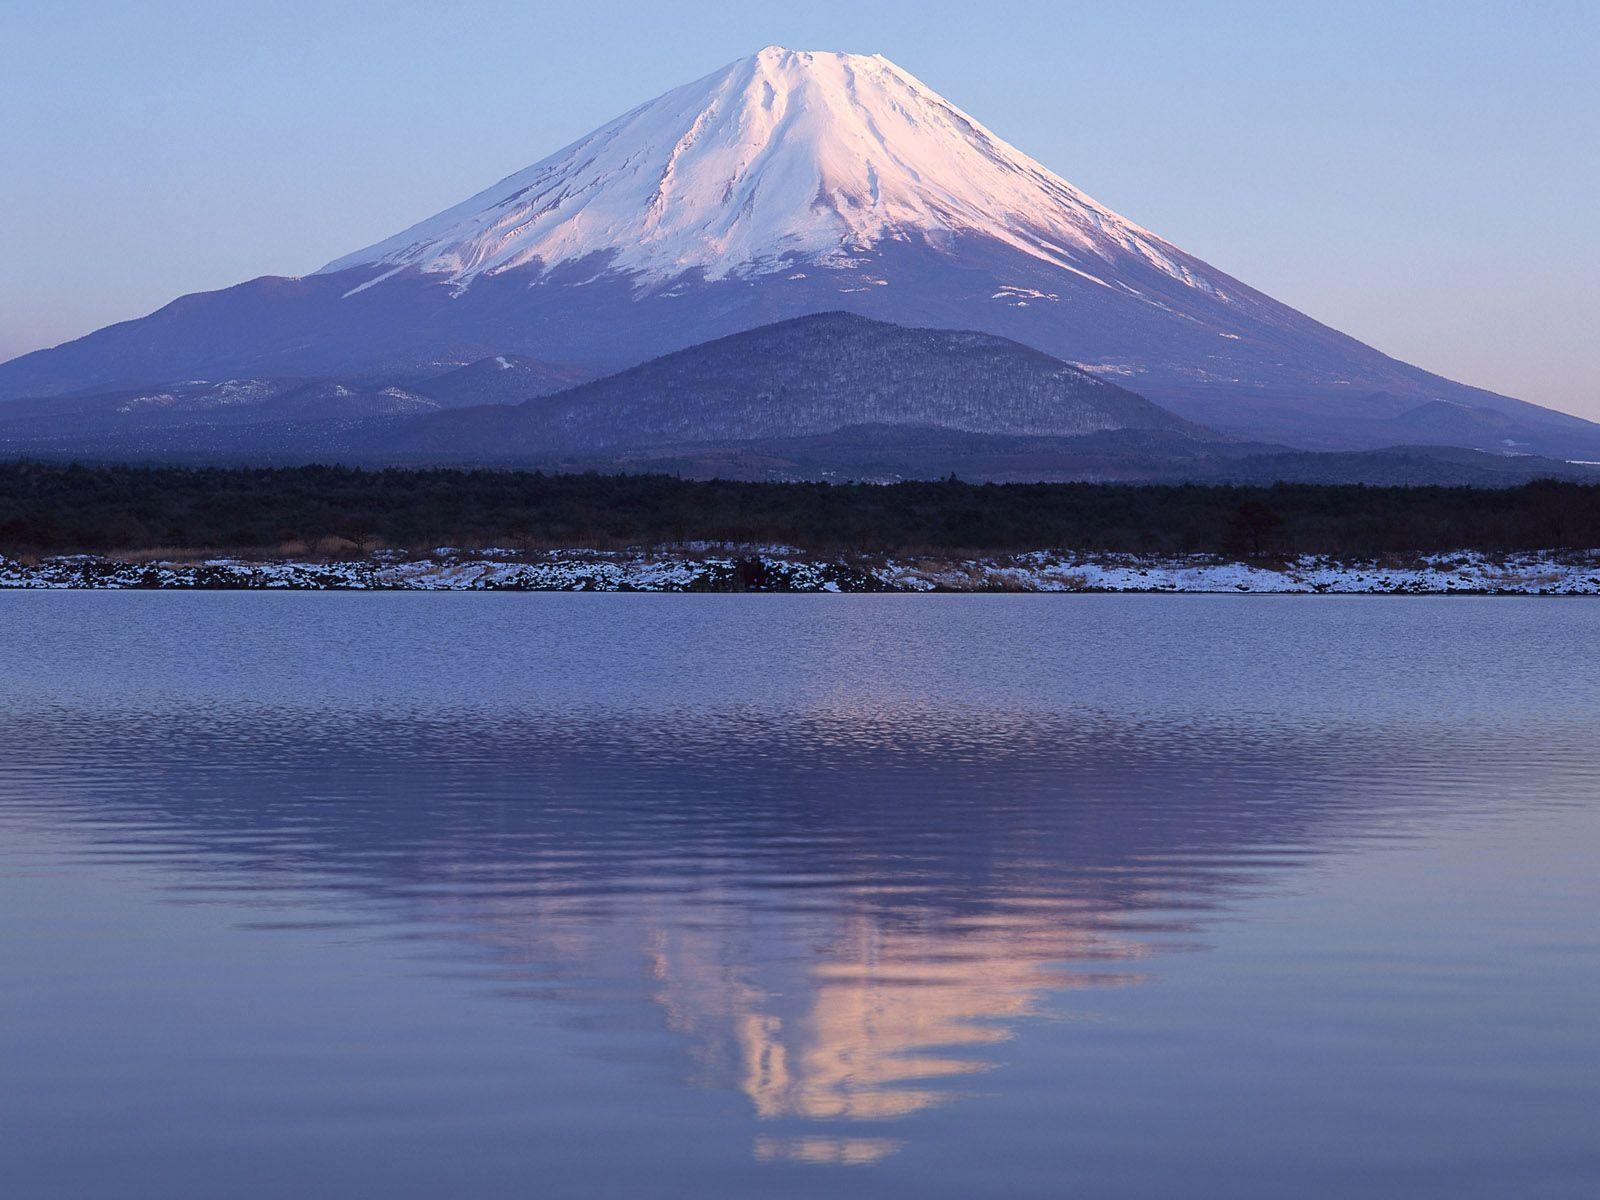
[0,547,1600,595]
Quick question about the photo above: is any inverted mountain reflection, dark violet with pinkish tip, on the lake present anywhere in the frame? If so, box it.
[11,704,1576,1163]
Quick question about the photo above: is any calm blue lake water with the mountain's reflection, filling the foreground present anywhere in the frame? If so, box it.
[0,594,1600,1200]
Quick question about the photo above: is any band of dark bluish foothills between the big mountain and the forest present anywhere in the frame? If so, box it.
[0,320,1597,486]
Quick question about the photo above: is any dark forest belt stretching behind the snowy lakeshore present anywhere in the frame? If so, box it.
[0,462,1600,557]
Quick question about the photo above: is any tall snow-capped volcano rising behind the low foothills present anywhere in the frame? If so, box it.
[0,46,1600,459]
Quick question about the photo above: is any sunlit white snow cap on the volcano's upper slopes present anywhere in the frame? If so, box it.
[323,46,1213,296]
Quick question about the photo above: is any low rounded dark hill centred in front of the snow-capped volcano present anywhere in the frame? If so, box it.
[368,312,1214,461]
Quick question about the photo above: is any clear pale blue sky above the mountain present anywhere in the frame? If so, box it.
[0,0,1600,419]
